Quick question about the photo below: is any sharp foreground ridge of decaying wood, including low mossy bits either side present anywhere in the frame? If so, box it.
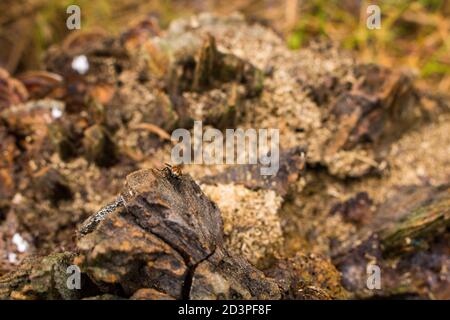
[0,169,342,299]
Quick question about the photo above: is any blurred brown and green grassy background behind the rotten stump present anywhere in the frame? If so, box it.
[0,0,450,93]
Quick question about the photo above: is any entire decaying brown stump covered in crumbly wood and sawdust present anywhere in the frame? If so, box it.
[0,14,450,299]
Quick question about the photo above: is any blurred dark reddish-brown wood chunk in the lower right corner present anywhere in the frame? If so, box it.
[333,185,450,297]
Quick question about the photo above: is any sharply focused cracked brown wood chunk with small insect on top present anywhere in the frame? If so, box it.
[78,170,278,298]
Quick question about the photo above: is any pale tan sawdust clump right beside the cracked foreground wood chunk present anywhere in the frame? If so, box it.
[201,184,284,267]
